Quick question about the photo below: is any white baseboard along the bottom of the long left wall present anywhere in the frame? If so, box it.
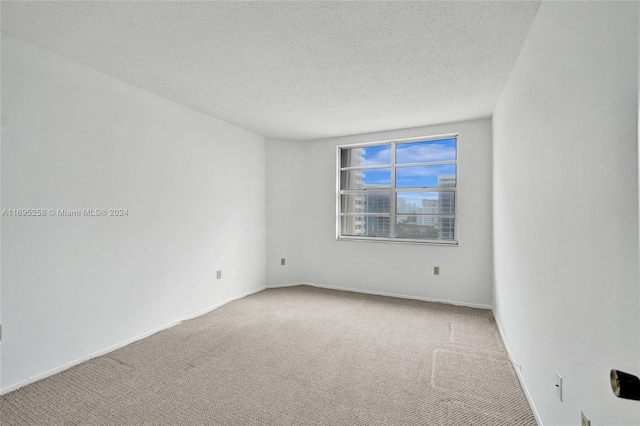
[0,286,266,395]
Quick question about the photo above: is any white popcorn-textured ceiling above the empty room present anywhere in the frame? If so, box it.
[2,1,539,140]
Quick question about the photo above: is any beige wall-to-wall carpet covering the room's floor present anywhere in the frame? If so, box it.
[0,286,536,426]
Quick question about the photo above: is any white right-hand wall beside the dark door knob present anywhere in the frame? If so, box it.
[493,2,640,426]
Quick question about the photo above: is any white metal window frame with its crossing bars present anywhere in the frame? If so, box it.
[336,133,460,247]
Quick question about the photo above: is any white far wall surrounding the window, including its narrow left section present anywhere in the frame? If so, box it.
[267,119,492,306]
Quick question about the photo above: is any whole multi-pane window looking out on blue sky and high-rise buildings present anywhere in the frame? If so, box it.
[337,134,458,245]
